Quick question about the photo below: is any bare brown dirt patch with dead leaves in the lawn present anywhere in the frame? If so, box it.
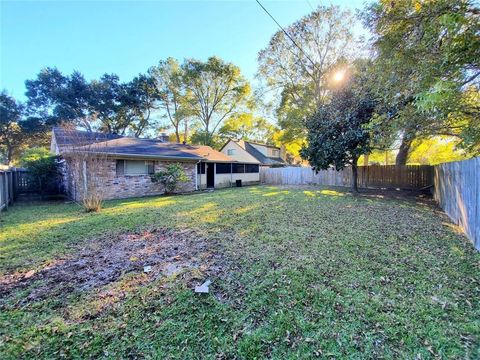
[0,228,225,303]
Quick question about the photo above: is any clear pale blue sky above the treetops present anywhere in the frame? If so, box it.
[0,0,364,100]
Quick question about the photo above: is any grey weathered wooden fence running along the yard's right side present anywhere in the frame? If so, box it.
[434,157,480,250]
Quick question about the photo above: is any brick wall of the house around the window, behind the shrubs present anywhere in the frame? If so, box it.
[67,159,196,201]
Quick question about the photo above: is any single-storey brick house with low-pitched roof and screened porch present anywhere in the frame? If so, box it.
[51,128,260,201]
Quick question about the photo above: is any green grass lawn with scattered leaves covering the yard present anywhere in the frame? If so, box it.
[0,187,480,359]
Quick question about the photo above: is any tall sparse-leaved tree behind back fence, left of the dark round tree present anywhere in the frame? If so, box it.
[258,6,358,152]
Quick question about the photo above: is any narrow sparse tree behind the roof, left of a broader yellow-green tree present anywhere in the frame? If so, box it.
[149,58,188,143]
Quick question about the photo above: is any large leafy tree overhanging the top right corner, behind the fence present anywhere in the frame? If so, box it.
[363,0,480,164]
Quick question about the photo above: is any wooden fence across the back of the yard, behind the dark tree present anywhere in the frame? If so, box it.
[260,165,433,190]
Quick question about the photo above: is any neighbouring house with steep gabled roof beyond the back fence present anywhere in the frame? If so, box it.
[220,139,287,167]
